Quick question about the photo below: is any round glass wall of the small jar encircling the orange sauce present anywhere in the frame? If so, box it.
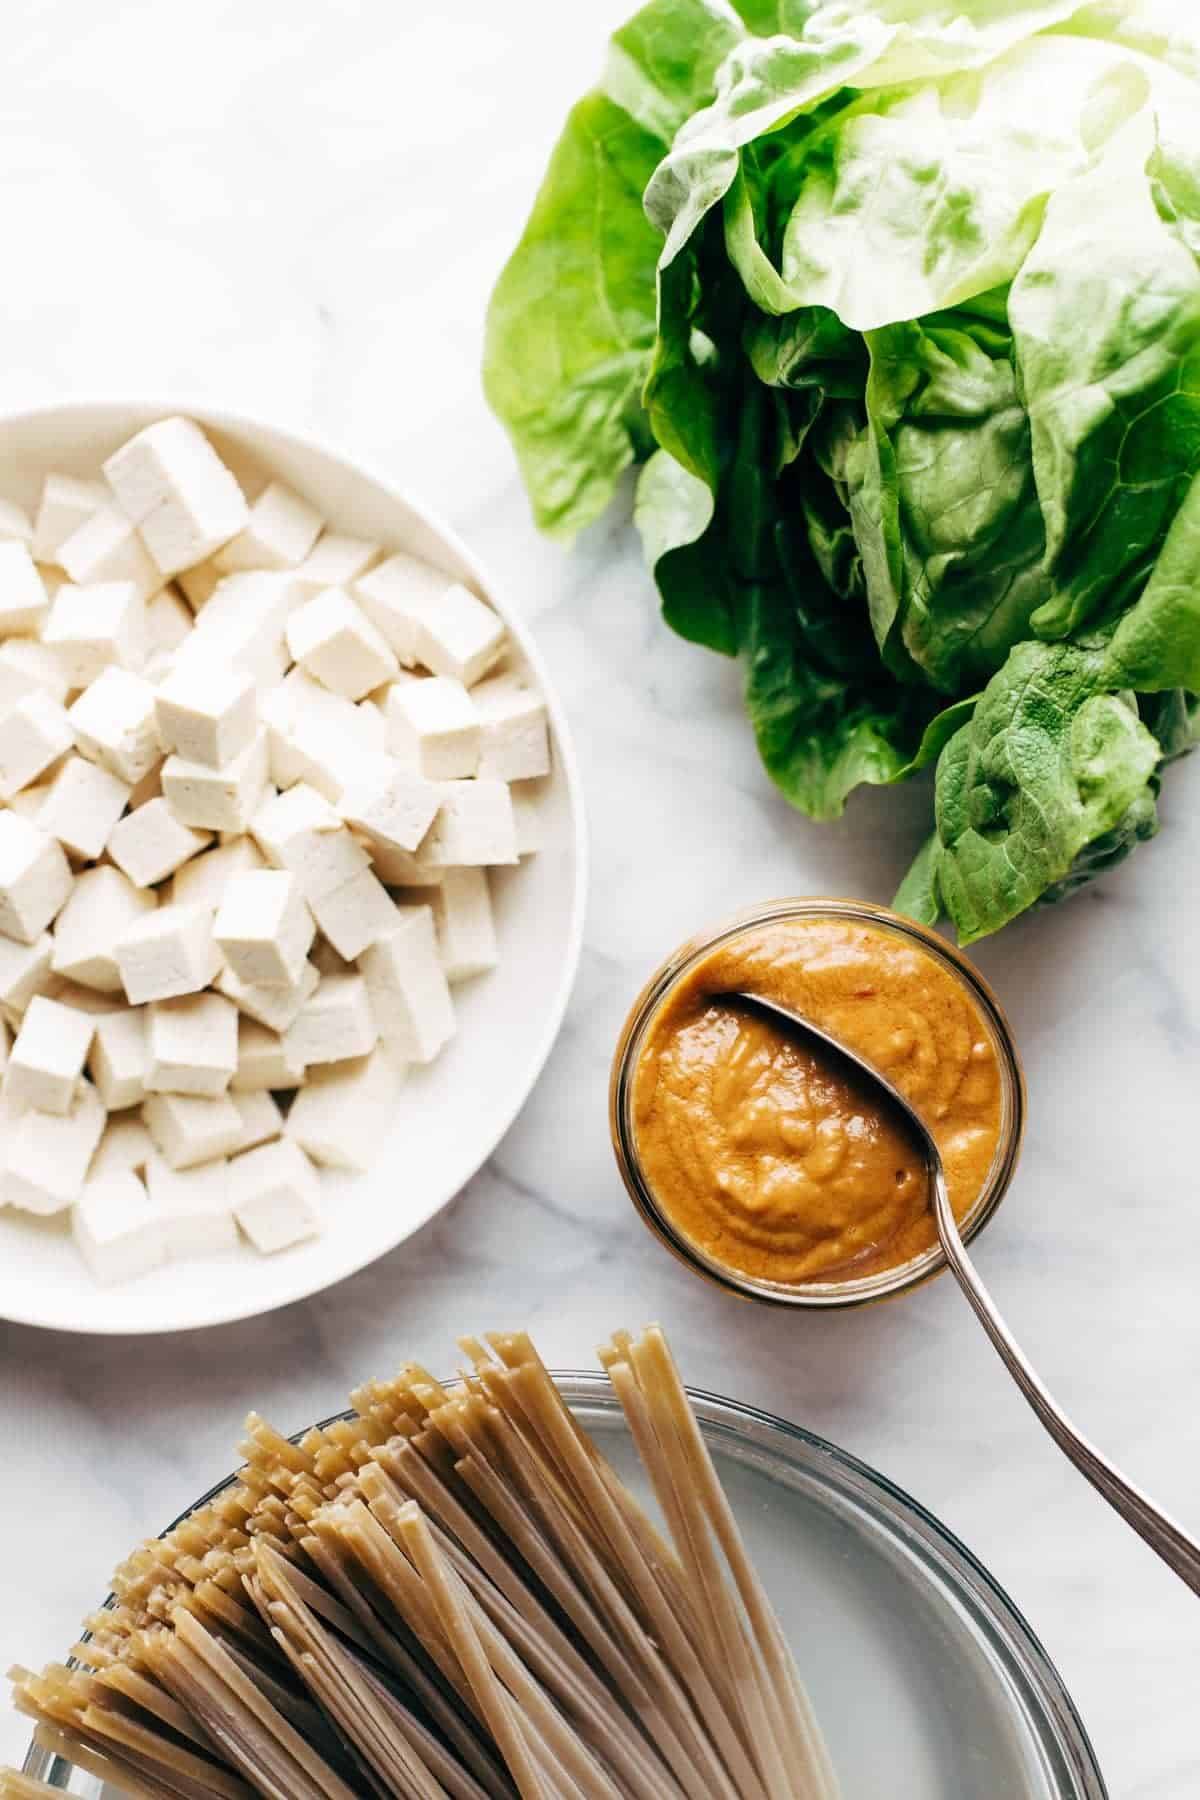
[608,898,1025,1307]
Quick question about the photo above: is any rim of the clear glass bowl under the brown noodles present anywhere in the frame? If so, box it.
[23,1370,1108,1800]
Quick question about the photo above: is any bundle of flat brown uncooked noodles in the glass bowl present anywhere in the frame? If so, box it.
[0,1327,837,1800]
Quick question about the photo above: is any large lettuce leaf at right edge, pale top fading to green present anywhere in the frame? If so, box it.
[1009,112,1200,640]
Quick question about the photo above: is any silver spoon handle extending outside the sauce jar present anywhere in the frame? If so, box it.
[930,1163,1200,1595]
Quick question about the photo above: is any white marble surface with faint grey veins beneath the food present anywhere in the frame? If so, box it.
[0,0,1200,1800]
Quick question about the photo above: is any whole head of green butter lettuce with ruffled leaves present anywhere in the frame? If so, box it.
[486,0,1200,941]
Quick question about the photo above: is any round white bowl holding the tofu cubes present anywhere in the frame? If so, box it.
[0,401,587,1332]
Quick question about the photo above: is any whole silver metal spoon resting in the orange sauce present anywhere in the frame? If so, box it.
[734,994,1200,1593]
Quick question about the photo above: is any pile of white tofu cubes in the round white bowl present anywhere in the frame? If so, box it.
[0,418,549,1282]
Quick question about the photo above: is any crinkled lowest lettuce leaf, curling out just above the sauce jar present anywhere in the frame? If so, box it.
[936,643,1160,943]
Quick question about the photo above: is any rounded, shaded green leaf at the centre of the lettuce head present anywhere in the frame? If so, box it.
[849,313,1051,693]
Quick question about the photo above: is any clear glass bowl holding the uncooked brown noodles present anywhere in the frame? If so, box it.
[25,1373,1108,1800]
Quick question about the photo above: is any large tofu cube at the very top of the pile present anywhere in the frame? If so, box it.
[104,418,248,585]
